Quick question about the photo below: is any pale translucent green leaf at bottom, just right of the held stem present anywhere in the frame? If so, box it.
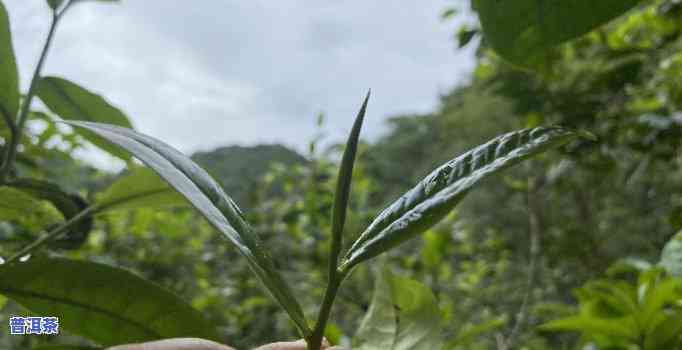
[355,270,443,350]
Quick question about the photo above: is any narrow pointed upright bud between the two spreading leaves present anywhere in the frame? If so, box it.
[330,91,371,268]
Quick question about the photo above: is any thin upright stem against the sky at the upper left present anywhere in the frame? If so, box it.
[0,2,73,183]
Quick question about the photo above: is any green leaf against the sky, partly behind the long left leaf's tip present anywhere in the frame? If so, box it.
[36,77,132,160]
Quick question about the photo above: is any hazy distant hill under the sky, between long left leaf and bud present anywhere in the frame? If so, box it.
[192,145,306,208]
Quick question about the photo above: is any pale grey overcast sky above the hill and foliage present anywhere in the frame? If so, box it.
[4,0,474,168]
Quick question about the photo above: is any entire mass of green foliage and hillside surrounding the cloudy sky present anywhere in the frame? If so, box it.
[0,0,682,350]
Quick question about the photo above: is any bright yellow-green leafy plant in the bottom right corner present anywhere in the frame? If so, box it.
[540,234,682,350]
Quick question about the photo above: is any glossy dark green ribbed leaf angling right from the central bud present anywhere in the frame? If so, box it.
[341,127,576,269]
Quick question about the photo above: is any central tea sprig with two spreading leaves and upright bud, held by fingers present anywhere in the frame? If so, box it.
[59,92,576,349]
